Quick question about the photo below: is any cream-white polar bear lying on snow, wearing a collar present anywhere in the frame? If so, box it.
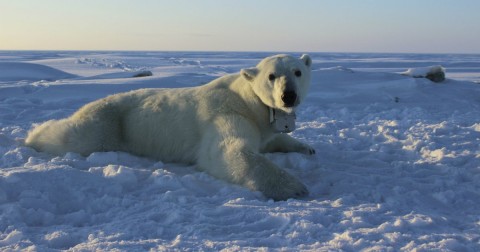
[25,54,315,200]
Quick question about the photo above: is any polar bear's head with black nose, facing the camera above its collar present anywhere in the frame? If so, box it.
[240,54,312,113]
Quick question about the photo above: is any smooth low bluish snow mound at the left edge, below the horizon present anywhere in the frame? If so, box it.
[0,62,77,82]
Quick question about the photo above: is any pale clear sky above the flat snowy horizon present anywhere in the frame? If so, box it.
[0,0,480,53]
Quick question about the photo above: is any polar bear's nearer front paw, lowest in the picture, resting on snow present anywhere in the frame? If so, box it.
[263,171,308,201]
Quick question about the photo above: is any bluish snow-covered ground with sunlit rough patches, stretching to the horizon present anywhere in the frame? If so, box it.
[0,51,480,251]
